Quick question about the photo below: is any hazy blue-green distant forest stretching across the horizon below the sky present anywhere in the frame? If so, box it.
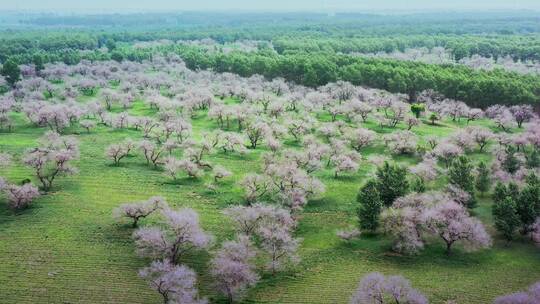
[4,13,539,63]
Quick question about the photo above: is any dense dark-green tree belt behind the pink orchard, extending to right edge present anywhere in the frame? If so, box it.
[167,46,539,107]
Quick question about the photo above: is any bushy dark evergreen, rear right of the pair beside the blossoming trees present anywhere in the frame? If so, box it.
[376,162,409,207]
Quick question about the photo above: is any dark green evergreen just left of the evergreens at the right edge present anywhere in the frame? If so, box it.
[492,197,520,242]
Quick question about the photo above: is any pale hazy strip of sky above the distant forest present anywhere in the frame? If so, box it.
[0,0,540,12]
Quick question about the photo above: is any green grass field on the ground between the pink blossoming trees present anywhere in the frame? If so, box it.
[0,98,540,304]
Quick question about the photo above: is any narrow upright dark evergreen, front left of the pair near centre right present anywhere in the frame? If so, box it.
[356,180,383,231]
